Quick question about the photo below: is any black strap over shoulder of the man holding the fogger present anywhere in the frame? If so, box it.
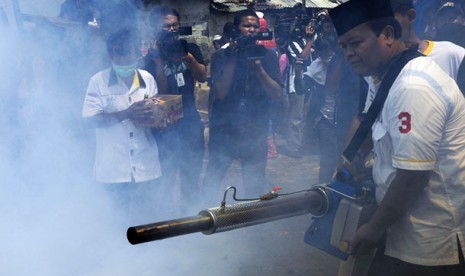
[342,48,423,163]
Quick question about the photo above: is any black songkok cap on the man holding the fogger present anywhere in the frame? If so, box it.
[329,0,394,36]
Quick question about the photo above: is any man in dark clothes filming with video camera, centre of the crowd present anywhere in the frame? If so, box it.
[204,10,284,203]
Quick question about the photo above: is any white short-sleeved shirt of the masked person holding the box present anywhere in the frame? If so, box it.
[82,68,161,183]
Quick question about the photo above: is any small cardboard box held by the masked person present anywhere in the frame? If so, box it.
[137,95,183,127]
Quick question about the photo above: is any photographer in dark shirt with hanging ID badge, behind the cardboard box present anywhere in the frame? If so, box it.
[139,6,206,209]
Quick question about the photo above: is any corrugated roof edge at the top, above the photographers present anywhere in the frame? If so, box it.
[211,0,344,12]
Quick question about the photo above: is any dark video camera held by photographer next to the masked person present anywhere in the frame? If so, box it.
[157,27,192,59]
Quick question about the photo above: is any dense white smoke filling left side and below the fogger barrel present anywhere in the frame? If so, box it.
[0,1,336,276]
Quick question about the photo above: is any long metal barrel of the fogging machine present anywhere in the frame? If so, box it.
[127,188,330,244]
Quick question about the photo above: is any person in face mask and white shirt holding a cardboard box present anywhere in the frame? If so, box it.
[82,29,164,218]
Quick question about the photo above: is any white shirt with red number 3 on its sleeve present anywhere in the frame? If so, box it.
[372,57,465,265]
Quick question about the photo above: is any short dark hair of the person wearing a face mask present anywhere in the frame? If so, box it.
[106,28,140,58]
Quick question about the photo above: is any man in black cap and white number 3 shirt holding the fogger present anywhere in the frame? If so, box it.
[330,0,465,275]
